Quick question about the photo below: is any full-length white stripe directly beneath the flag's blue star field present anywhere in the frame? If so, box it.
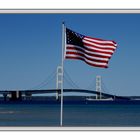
[67,44,112,57]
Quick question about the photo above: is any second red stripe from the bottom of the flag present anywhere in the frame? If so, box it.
[66,52,108,63]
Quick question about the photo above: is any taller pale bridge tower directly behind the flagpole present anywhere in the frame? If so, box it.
[56,66,63,100]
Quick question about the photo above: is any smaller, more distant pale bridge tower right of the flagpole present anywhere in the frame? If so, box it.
[96,75,102,99]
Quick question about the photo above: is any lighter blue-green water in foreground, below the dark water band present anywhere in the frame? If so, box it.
[0,103,140,127]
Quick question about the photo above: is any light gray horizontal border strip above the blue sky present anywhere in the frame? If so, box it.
[0,9,140,14]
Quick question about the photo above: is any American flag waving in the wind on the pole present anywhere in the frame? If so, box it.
[65,28,117,68]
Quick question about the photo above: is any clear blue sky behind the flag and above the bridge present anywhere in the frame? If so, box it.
[0,14,140,95]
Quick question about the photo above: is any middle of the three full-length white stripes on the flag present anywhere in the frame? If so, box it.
[67,49,109,61]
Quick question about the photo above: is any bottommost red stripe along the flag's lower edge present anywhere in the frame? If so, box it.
[66,56,108,68]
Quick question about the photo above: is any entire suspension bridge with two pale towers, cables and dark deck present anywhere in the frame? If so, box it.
[0,66,129,101]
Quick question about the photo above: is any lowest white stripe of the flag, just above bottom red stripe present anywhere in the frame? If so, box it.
[66,54,107,66]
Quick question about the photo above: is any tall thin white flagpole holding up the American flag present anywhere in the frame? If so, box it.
[60,22,65,126]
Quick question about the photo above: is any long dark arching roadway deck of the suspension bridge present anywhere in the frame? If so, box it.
[0,89,130,100]
